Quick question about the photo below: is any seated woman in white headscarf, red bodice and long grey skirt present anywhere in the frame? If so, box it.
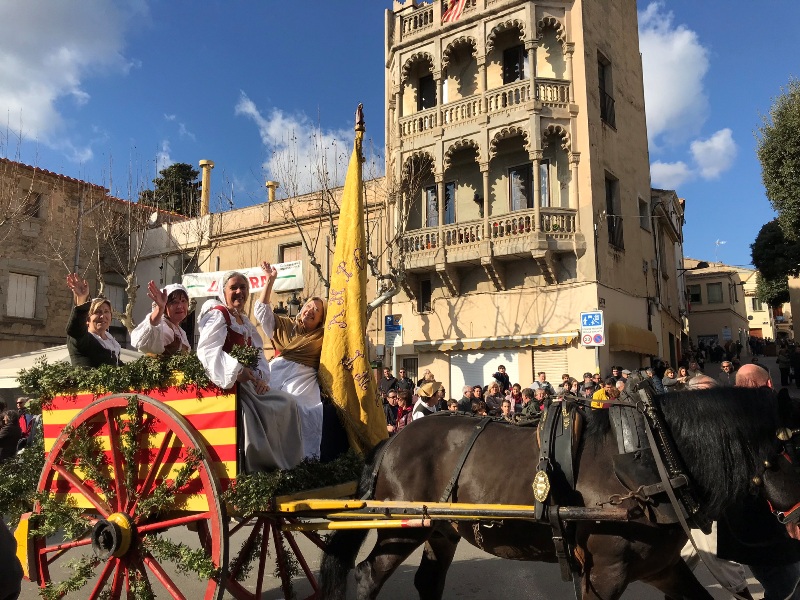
[197,271,303,472]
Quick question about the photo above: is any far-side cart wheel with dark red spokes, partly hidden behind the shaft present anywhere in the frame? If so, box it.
[225,514,325,600]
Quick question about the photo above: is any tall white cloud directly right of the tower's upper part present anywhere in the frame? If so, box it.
[639,2,709,149]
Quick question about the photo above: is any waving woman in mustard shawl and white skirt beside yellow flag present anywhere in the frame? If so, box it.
[255,261,325,457]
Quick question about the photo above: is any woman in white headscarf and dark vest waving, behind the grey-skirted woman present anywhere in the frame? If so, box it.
[131,281,191,355]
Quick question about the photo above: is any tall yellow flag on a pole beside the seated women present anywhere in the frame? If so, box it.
[319,105,388,453]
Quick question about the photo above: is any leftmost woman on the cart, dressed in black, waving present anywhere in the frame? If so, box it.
[67,273,121,368]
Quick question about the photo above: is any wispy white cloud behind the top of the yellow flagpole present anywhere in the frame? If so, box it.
[236,92,353,196]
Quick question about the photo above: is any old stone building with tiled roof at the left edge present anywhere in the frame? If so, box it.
[0,159,124,356]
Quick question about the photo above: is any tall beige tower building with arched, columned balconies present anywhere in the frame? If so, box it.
[385,0,684,395]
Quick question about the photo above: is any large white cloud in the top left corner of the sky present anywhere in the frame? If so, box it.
[0,0,145,160]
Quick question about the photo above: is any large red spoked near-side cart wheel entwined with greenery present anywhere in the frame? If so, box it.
[33,394,228,600]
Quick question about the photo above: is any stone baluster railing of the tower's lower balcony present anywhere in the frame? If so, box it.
[402,207,577,254]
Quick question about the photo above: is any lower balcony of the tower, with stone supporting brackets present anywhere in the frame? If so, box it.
[401,208,586,294]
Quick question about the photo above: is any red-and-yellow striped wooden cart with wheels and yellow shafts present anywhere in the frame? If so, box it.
[15,386,624,600]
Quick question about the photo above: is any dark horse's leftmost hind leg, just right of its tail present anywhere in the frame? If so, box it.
[354,527,431,600]
